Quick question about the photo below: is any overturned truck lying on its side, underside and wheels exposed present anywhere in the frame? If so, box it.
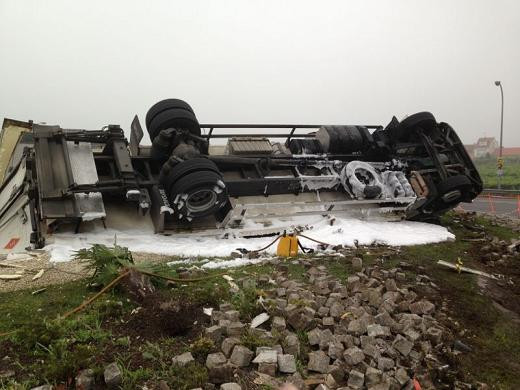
[0,99,482,253]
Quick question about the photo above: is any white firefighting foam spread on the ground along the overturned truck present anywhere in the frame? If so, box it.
[44,217,454,268]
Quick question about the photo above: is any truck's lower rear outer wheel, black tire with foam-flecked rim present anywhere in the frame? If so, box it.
[169,171,228,221]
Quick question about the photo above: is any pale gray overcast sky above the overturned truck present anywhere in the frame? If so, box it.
[0,0,520,146]
